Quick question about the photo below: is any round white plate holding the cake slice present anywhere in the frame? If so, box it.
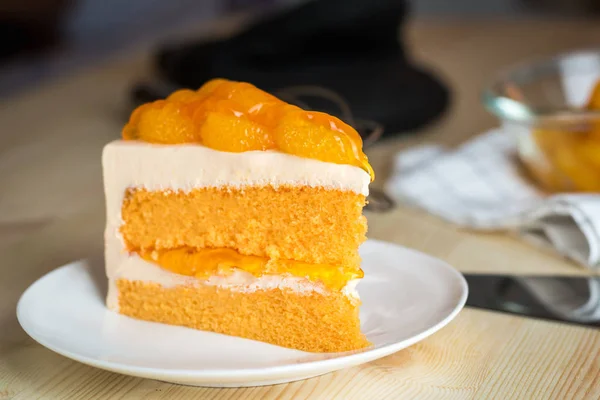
[17,240,468,387]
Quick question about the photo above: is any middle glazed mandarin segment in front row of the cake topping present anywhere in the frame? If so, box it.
[200,112,274,153]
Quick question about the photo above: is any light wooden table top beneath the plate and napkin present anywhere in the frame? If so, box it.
[0,20,600,399]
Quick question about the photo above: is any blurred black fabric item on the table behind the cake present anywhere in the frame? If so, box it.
[137,0,449,134]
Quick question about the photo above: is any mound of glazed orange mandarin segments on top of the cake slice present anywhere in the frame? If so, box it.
[123,79,375,180]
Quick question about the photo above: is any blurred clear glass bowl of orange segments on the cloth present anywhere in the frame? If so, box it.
[483,50,600,192]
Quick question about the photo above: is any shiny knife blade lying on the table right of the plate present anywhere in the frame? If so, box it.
[464,274,600,328]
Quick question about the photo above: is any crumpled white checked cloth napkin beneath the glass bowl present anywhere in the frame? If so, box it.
[386,129,600,321]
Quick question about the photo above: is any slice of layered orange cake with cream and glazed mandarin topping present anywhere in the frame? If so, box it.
[102,79,373,352]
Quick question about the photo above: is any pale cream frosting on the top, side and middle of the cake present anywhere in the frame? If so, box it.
[102,140,370,309]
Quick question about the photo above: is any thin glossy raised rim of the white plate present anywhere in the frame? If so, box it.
[16,239,469,381]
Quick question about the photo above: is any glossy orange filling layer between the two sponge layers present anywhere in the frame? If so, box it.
[139,247,363,290]
